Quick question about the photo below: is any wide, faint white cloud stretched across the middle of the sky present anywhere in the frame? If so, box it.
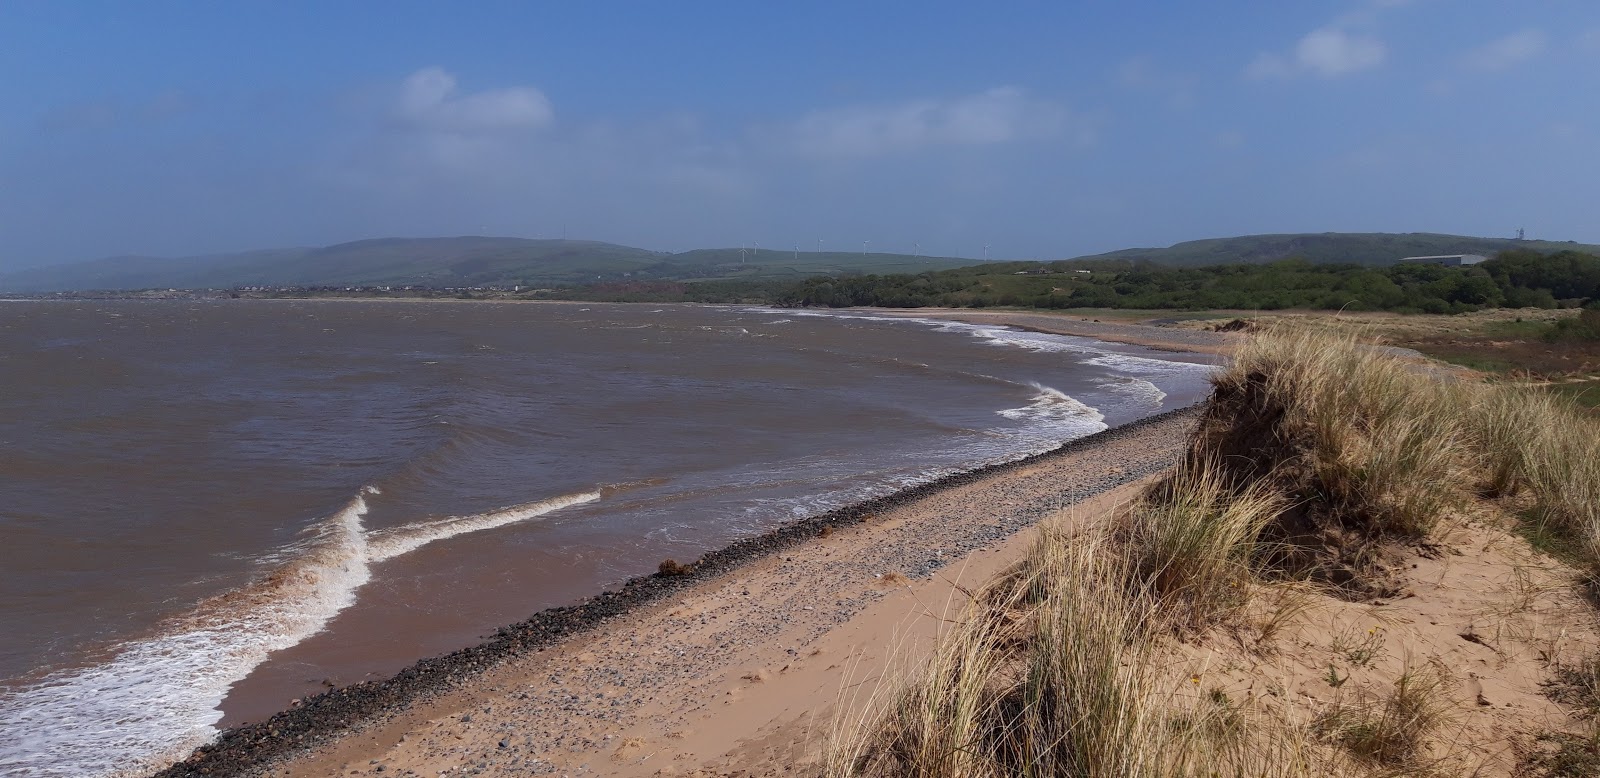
[786,86,1085,157]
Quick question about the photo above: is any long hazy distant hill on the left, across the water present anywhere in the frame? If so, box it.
[0,237,974,293]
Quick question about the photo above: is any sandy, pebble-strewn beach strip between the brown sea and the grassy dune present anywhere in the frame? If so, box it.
[172,410,1195,776]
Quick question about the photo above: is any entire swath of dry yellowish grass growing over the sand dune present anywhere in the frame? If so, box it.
[826,331,1600,778]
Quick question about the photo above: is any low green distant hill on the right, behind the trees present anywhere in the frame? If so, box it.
[1075,232,1600,267]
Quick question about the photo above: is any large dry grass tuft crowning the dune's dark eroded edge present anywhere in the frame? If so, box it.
[1192,333,1464,538]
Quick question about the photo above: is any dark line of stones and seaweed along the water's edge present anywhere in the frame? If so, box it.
[152,405,1198,778]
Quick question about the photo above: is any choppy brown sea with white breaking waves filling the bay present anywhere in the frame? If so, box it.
[0,299,1211,776]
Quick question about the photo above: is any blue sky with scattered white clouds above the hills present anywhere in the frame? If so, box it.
[0,0,1600,271]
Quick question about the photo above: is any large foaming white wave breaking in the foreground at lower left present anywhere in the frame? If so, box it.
[0,487,600,778]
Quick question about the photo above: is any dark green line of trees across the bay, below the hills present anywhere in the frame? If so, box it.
[542,250,1600,314]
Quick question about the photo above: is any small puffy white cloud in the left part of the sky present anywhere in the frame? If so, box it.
[397,67,555,133]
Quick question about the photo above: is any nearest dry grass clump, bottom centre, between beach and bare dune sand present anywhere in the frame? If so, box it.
[826,472,1344,776]
